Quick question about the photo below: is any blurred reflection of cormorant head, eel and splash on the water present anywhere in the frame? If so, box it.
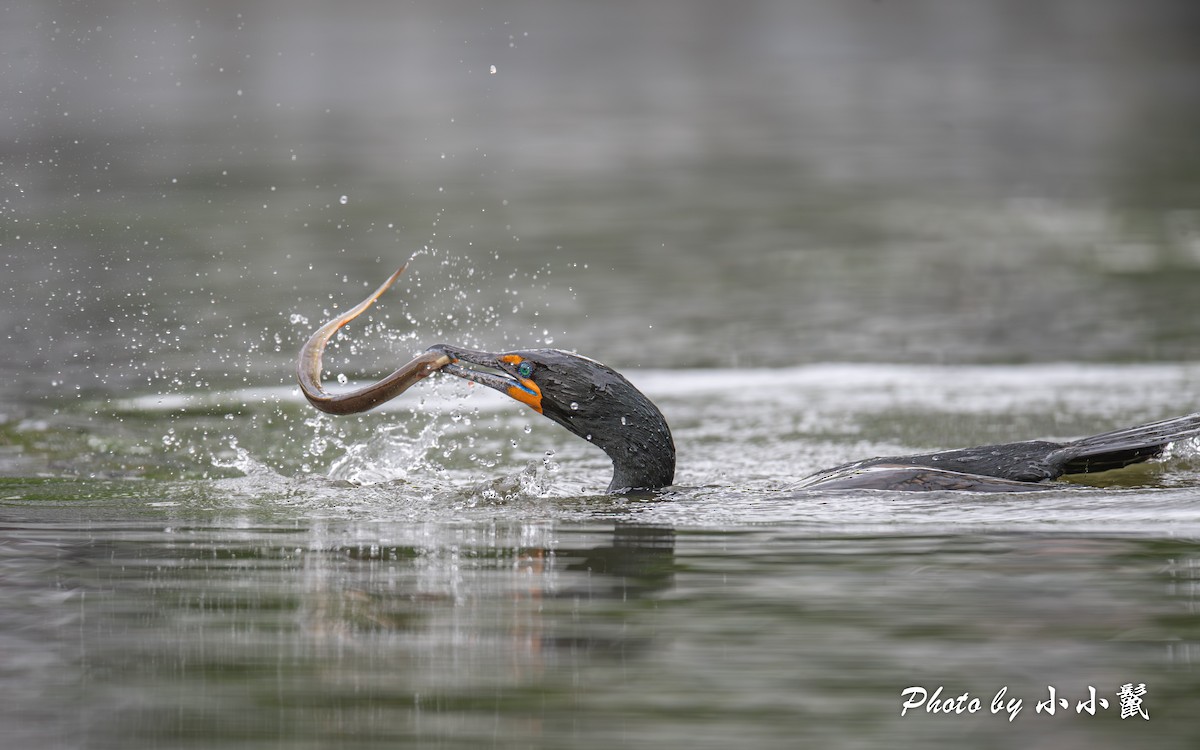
[304,523,676,678]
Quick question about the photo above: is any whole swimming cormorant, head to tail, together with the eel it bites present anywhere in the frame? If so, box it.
[298,268,1200,492]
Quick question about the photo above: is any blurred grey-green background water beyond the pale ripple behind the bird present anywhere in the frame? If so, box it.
[0,0,1200,398]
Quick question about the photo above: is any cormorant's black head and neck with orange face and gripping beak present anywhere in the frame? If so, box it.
[427,344,674,492]
